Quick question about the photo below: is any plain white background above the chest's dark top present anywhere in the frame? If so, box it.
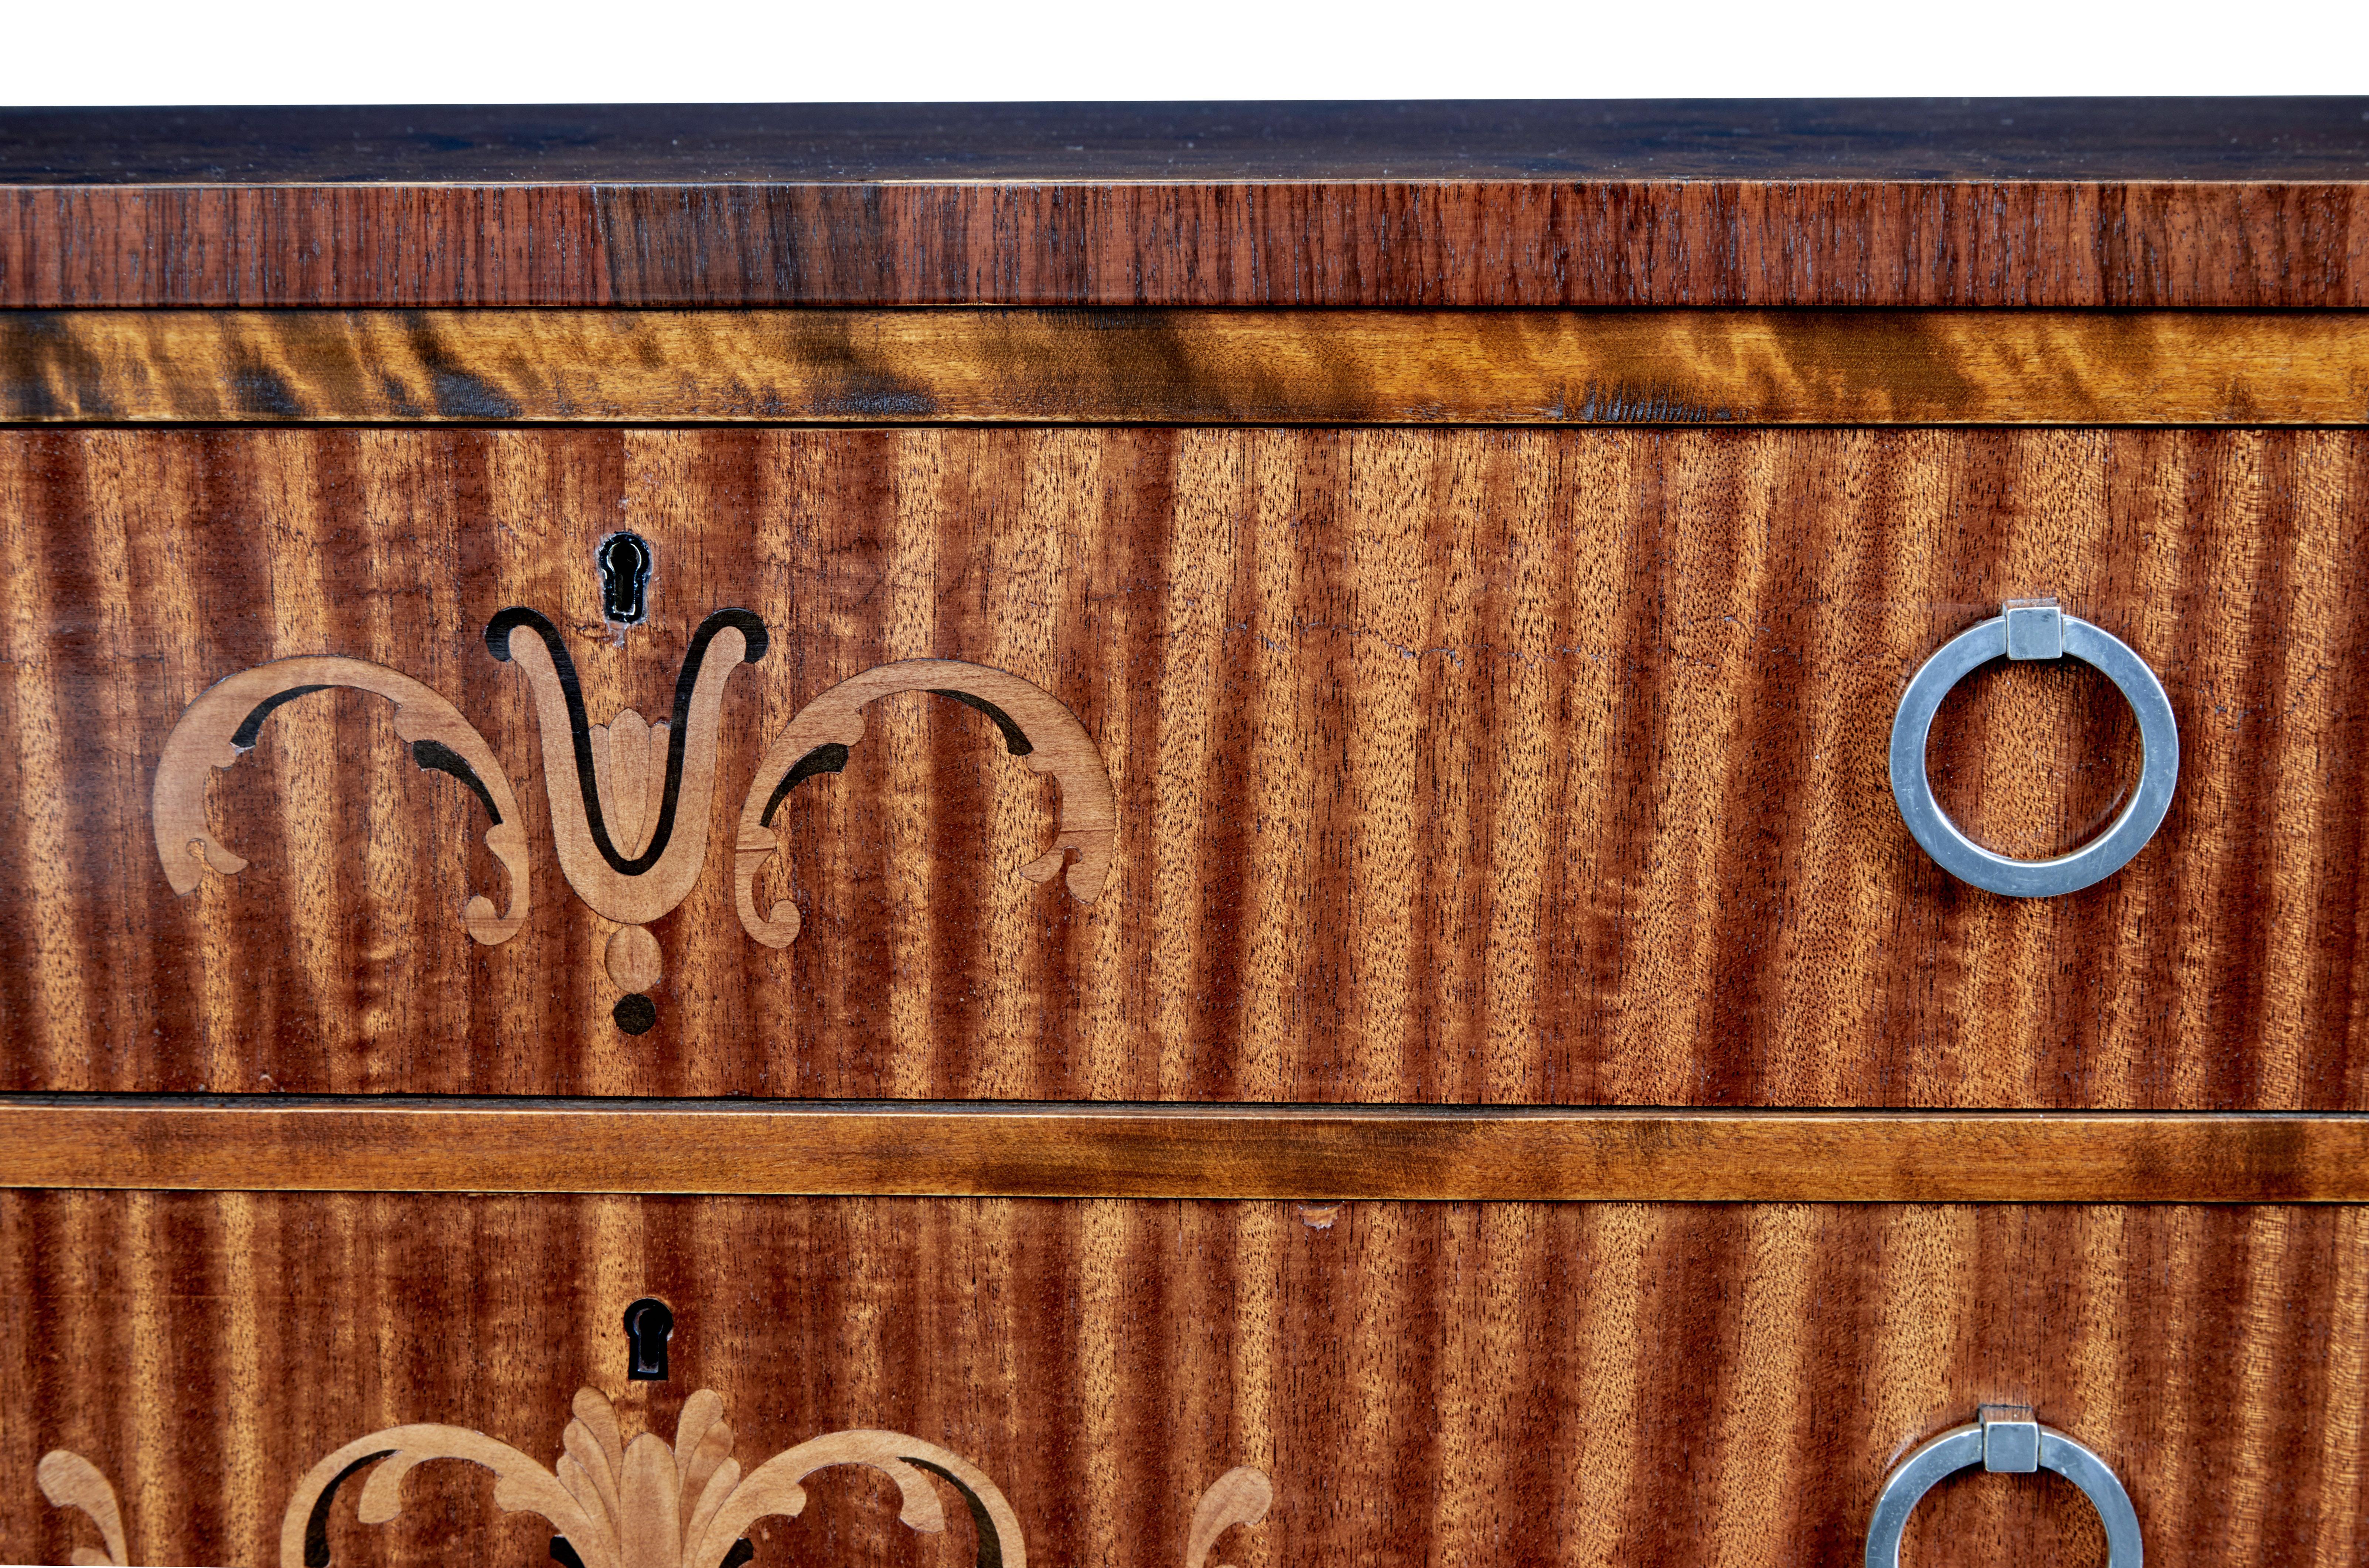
[0,0,2369,104]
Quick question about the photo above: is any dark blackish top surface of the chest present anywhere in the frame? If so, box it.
[0,97,2369,185]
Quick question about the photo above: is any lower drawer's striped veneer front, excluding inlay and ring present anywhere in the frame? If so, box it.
[0,1192,2369,1568]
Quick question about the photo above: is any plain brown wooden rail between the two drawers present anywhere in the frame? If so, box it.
[0,1097,2369,1203]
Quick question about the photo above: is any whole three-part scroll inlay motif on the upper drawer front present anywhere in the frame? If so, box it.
[151,606,1118,1033]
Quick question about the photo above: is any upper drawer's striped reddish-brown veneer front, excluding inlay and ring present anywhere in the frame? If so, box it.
[0,429,2369,1108]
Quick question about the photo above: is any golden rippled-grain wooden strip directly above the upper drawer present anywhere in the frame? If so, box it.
[0,308,2369,426]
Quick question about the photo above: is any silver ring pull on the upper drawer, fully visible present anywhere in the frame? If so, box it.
[1893,599,2179,898]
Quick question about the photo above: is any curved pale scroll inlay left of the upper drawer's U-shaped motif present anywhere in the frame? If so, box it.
[149,656,528,945]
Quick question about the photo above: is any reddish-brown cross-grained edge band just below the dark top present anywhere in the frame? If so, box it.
[0,181,2369,308]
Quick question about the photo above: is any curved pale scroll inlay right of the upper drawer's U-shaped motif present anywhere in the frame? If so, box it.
[732,658,1118,947]
